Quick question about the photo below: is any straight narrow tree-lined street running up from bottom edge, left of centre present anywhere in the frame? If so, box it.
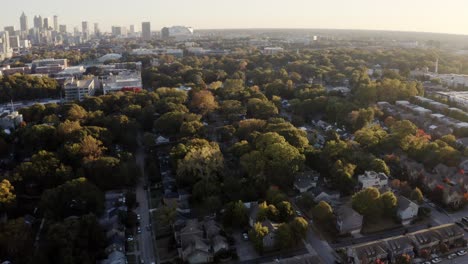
[135,136,156,263]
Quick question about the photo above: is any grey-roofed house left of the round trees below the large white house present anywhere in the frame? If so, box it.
[335,205,363,234]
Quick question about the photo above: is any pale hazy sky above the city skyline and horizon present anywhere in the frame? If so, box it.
[0,0,468,35]
